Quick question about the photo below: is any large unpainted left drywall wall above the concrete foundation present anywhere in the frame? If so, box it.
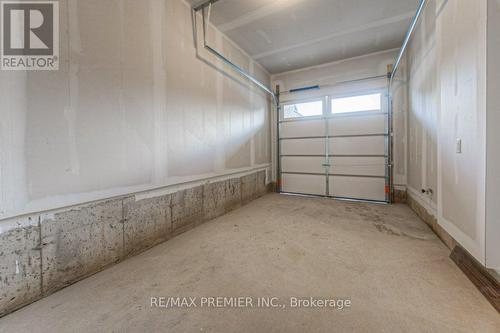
[0,0,271,219]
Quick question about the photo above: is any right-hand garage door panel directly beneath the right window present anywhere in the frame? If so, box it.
[328,114,387,136]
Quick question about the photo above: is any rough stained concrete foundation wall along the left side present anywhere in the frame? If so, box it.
[0,170,269,316]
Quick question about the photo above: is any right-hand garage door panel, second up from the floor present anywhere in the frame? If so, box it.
[330,157,386,177]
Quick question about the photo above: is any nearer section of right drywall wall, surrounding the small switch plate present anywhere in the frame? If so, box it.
[437,0,486,263]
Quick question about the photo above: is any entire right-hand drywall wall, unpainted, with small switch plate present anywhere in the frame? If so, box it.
[408,0,486,263]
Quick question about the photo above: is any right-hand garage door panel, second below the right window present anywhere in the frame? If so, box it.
[330,136,386,155]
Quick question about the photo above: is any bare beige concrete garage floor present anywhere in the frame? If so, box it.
[0,194,500,333]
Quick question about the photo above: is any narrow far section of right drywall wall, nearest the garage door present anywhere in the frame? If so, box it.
[407,1,439,210]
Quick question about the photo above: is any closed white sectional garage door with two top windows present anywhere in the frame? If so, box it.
[280,91,389,202]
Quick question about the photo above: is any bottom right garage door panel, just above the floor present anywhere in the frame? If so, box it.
[329,176,386,201]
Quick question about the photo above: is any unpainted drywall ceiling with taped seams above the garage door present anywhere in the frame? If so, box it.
[191,0,419,74]
